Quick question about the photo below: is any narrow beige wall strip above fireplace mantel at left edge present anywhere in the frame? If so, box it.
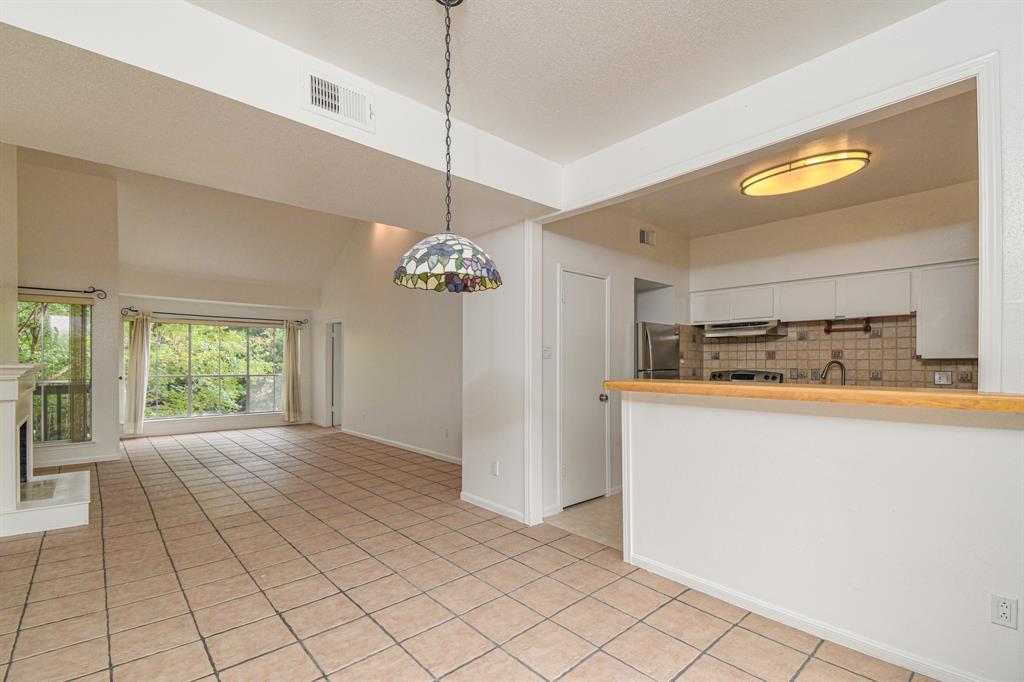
[0,142,17,364]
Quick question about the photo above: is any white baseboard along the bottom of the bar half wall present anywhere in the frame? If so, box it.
[629,553,994,682]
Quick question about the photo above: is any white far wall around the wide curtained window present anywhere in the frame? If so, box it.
[119,289,312,437]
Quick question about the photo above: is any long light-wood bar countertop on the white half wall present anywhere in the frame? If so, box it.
[604,379,1024,415]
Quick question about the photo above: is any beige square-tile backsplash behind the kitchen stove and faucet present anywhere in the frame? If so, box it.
[680,315,978,389]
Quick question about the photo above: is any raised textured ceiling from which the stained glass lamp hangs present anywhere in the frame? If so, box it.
[193,0,936,163]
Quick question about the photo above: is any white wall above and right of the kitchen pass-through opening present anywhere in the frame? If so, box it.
[562,2,1024,392]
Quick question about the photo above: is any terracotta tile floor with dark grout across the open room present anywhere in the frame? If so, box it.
[0,426,924,682]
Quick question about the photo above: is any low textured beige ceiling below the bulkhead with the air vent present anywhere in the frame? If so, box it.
[0,24,553,237]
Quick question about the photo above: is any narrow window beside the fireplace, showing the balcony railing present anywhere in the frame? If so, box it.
[17,296,92,442]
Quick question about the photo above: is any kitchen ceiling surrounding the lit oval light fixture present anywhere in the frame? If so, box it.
[602,82,978,237]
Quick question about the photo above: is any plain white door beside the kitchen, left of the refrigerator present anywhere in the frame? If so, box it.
[559,271,608,507]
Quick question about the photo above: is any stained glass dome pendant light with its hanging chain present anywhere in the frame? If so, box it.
[394,0,502,294]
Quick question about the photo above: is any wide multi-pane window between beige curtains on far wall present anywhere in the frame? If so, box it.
[135,323,285,419]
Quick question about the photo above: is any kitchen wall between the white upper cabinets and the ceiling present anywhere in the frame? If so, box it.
[689,182,978,291]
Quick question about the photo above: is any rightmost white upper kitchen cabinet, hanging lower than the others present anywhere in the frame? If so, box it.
[915,263,978,358]
